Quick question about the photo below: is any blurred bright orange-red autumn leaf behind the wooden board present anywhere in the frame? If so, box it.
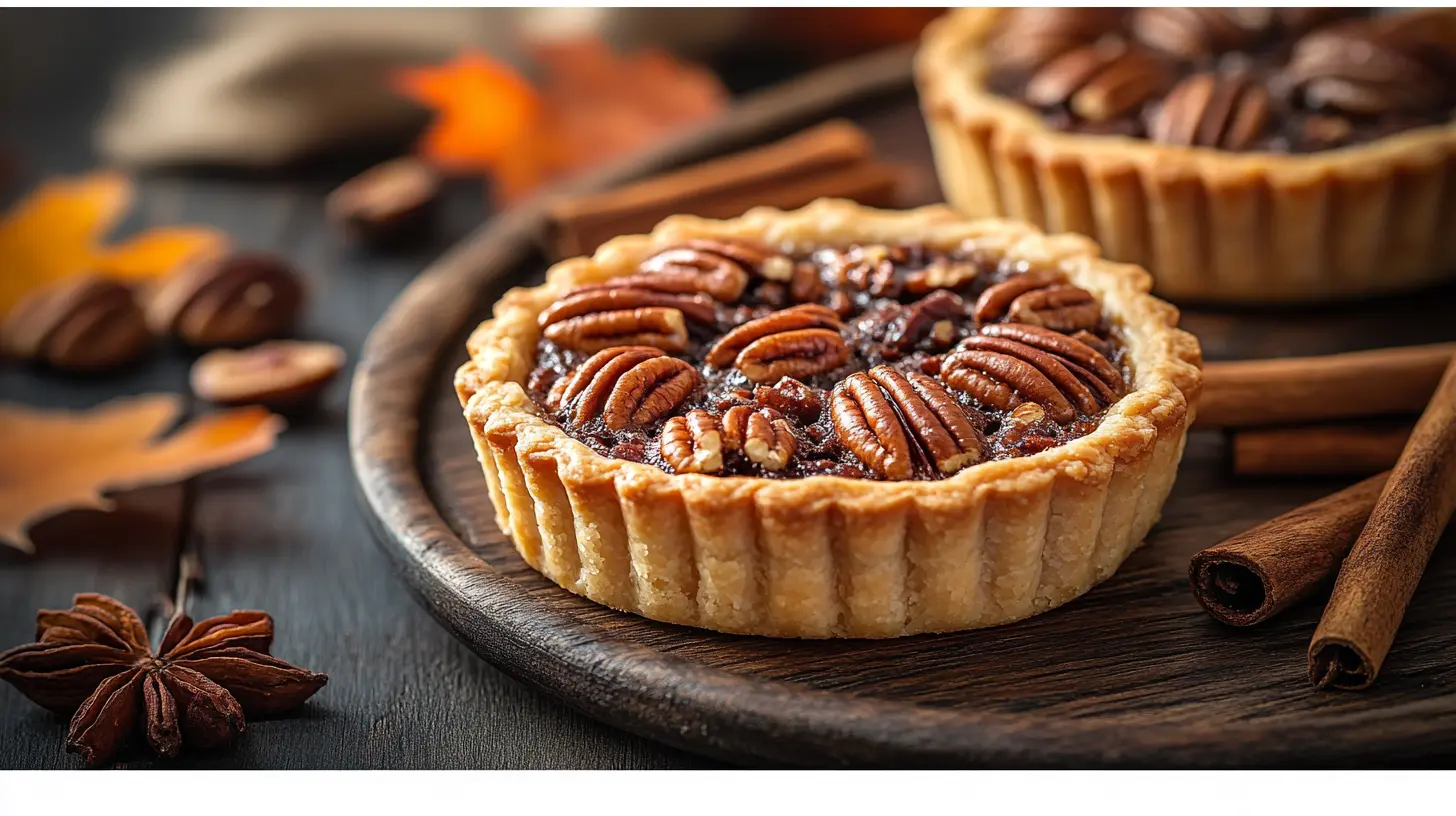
[395,38,728,203]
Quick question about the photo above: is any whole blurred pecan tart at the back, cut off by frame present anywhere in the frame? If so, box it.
[916,9,1456,302]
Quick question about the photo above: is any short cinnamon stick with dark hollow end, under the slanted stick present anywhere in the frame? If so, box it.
[1188,472,1390,627]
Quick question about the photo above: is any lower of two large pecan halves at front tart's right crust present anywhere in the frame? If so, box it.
[941,323,1121,423]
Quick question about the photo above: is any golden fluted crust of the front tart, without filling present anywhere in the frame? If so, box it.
[456,201,1201,638]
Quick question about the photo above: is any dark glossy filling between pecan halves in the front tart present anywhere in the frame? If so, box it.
[527,238,1128,479]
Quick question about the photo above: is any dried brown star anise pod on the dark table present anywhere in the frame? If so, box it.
[0,593,329,765]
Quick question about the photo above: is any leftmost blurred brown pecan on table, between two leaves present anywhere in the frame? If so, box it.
[0,275,151,372]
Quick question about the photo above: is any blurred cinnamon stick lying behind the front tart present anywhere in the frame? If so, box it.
[546,119,901,258]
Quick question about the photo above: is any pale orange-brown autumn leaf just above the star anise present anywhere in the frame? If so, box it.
[0,393,284,552]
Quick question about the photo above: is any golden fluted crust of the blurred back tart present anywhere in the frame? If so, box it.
[916,9,1456,302]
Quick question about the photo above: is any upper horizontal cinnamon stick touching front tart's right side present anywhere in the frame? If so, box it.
[1197,342,1456,428]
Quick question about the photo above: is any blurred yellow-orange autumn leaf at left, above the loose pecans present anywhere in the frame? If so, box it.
[0,173,227,318]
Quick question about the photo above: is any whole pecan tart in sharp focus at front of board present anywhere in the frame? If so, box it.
[456,201,1201,638]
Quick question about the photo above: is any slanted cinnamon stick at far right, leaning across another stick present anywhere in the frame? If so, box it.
[1309,363,1456,689]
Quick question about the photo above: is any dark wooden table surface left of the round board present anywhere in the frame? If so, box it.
[0,10,708,768]
